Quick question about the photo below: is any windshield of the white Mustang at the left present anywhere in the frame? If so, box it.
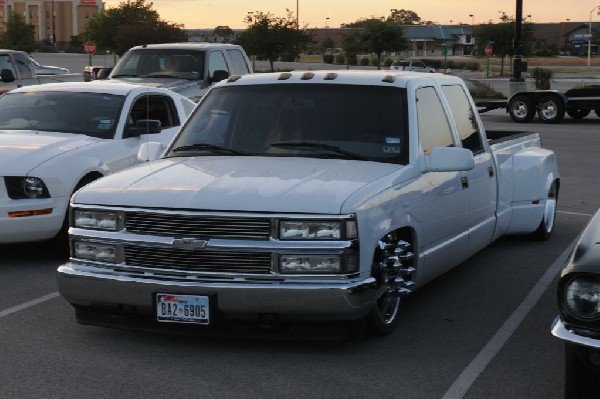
[0,91,125,139]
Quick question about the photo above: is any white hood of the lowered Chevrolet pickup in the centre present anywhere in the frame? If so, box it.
[73,156,404,214]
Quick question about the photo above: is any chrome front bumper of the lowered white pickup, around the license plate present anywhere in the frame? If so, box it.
[57,262,385,320]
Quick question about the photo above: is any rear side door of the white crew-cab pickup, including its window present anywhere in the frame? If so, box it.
[442,85,497,253]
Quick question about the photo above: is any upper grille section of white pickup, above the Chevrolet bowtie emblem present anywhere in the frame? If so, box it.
[125,212,271,240]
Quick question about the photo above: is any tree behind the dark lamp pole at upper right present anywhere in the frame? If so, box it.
[473,13,533,75]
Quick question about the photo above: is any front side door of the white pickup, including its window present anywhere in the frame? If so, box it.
[415,86,469,279]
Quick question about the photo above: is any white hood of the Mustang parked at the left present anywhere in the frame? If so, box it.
[0,130,99,176]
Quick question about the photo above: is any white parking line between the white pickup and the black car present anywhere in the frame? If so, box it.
[442,237,579,399]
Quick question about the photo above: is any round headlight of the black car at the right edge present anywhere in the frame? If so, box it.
[564,275,600,319]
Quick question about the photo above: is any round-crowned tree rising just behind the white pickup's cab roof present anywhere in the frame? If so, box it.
[235,10,312,71]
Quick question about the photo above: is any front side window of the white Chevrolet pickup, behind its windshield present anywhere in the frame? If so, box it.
[416,87,454,155]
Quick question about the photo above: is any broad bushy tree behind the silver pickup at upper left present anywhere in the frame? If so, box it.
[86,0,187,54]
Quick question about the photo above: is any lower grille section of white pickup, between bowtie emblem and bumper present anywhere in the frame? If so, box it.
[125,245,271,274]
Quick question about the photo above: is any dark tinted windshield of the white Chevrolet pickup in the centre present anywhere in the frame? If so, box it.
[167,83,408,164]
